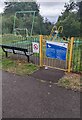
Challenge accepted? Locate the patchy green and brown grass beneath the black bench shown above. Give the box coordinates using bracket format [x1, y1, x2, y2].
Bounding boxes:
[0, 58, 39, 75]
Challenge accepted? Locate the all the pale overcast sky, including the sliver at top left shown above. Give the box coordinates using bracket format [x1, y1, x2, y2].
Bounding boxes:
[0, 0, 69, 23]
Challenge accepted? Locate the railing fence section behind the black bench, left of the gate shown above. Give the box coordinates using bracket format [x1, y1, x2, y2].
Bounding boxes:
[0, 34, 39, 65]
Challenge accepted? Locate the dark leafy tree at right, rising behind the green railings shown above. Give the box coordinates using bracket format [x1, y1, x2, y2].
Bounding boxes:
[56, 2, 81, 37]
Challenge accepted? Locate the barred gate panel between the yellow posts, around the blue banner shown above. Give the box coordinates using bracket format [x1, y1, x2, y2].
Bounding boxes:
[42, 36, 68, 71]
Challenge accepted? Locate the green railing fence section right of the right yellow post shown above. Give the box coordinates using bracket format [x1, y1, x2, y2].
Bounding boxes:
[72, 38, 82, 72]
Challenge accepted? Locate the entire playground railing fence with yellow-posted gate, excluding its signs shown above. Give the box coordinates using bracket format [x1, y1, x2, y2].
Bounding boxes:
[2, 34, 82, 72]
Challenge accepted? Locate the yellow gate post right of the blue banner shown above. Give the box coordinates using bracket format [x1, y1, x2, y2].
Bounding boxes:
[68, 37, 74, 72]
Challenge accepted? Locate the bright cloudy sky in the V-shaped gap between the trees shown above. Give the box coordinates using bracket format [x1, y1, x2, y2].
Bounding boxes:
[36, 0, 67, 23]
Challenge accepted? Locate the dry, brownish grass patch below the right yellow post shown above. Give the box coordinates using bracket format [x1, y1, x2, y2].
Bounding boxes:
[58, 73, 82, 92]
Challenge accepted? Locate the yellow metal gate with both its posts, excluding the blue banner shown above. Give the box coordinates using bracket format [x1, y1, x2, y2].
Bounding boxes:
[40, 35, 74, 72]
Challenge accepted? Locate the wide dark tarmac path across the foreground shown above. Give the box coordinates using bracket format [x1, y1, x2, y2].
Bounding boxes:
[2, 72, 80, 118]
